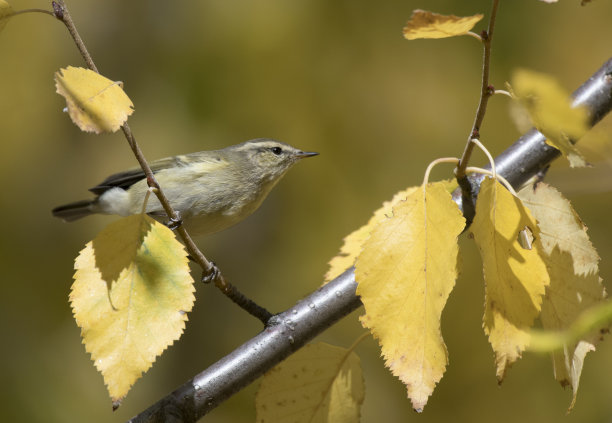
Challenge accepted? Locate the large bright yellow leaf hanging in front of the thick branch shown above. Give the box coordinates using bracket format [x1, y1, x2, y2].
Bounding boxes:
[355, 182, 465, 411]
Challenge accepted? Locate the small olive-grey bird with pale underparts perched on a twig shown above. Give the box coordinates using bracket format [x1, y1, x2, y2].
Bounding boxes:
[52, 138, 318, 235]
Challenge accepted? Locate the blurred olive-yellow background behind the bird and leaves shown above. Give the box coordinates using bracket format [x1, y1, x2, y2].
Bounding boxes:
[0, 0, 612, 423]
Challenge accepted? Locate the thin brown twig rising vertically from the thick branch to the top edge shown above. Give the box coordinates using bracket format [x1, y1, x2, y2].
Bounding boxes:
[455, 0, 499, 181]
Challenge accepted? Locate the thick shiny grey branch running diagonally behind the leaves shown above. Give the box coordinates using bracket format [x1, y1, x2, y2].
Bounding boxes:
[130, 59, 612, 423]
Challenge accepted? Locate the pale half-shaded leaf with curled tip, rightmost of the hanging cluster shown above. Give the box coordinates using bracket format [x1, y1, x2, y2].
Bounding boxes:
[519, 183, 606, 409]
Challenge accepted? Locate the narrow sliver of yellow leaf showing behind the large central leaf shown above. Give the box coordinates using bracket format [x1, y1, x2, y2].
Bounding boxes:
[325, 187, 418, 283]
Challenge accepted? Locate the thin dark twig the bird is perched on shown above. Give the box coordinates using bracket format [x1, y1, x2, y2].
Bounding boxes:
[51, 0, 272, 325]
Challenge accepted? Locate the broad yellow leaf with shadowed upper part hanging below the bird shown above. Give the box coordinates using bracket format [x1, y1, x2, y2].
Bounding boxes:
[70, 215, 194, 406]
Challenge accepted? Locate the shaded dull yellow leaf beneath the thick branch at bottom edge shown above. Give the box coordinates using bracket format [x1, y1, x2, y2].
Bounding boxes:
[255, 342, 365, 423]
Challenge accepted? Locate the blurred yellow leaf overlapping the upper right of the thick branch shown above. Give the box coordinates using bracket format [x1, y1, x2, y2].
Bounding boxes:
[512, 69, 589, 167]
